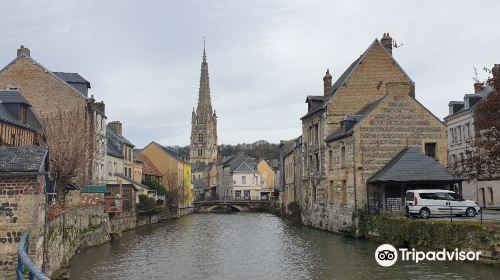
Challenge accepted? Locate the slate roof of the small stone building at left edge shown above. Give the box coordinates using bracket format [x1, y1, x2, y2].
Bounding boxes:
[0, 146, 48, 173]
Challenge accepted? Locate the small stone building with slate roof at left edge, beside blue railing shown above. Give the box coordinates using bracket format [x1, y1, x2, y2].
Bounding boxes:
[0, 146, 48, 279]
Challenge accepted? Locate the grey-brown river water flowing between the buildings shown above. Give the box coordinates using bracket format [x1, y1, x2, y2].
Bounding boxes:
[70, 212, 500, 280]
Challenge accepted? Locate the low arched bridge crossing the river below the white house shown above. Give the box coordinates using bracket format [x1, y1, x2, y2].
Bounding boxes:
[194, 200, 271, 213]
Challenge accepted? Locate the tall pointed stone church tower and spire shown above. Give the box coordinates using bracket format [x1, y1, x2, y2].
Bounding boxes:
[189, 48, 217, 164]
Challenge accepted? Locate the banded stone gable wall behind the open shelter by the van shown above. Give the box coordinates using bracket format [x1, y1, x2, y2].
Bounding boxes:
[354, 85, 448, 205]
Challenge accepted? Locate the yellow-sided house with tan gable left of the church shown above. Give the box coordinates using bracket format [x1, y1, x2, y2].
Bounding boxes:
[139, 142, 193, 215]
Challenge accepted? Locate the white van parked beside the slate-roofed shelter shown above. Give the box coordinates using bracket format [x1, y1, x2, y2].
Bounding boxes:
[405, 190, 481, 219]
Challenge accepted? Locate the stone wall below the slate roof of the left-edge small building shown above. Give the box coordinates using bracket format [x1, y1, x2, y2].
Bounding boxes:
[0, 175, 45, 279]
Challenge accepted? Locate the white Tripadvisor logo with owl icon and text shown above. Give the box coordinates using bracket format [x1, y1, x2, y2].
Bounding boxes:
[375, 244, 481, 267]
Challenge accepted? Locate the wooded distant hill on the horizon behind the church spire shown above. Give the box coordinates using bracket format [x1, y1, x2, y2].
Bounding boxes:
[170, 140, 279, 160]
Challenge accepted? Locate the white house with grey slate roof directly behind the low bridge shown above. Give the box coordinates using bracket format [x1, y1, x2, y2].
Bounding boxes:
[217, 153, 261, 200]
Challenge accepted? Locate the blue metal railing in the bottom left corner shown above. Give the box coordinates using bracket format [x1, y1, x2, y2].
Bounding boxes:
[16, 230, 50, 280]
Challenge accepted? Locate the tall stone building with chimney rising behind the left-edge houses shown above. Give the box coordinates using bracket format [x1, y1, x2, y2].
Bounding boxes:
[0, 46, 106, 186]
